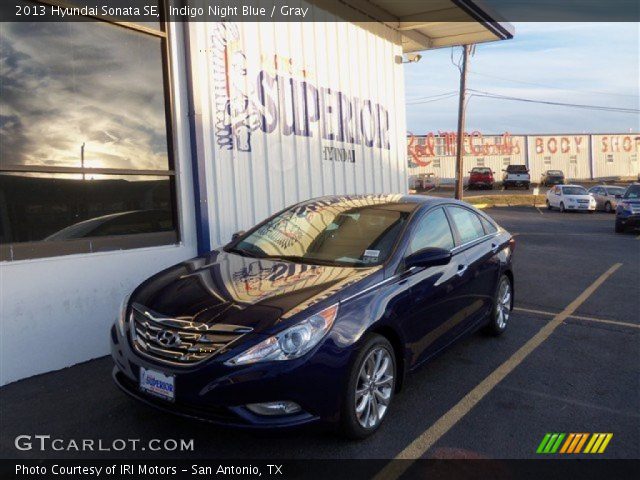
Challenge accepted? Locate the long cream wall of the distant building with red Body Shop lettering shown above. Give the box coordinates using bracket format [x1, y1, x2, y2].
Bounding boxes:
[407, 133, 640, 184]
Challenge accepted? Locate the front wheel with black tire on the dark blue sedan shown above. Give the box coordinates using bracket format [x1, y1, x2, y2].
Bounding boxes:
[340, 334, 397, 439]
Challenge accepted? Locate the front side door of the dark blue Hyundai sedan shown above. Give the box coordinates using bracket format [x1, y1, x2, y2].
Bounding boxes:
[399, 207, 471, 365]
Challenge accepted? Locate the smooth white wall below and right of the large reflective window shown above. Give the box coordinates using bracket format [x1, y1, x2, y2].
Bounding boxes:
[0, 23, 196, 385]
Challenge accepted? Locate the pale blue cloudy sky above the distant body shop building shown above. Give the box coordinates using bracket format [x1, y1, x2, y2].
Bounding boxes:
[405, 23, 640, 134]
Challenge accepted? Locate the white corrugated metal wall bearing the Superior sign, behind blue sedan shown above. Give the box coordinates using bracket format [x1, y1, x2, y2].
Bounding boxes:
[188, 15, 407, 245]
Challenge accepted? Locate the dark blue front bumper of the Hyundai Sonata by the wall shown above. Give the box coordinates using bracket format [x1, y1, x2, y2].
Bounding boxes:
[111, 326, 350, 428]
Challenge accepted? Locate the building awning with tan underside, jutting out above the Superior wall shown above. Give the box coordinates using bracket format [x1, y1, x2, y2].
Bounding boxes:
[344, 0, 514, 53]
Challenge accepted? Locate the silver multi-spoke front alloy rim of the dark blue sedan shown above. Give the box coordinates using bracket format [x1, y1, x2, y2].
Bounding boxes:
[355, 346, 394, 428]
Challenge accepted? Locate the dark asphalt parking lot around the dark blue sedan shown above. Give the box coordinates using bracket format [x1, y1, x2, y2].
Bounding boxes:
[0, 207, 640, 459]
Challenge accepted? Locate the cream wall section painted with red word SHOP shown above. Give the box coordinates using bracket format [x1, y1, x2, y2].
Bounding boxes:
[592, 133, 640, 177]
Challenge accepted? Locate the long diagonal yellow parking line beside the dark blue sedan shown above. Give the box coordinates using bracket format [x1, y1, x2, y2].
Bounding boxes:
[374, 263, 622, 480]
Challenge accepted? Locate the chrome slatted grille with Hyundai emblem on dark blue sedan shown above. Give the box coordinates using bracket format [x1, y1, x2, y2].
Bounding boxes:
[130, 303, 253, 365]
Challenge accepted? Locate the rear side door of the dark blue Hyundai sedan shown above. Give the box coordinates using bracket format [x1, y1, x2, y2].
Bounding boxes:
[446, 205, 500, 326]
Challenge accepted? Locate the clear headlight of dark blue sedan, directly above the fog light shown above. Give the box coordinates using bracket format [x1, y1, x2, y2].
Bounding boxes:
[225, 304, 338, 365]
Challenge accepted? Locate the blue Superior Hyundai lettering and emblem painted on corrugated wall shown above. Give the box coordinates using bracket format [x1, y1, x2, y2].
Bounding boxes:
[211, 22, 391, 157]
